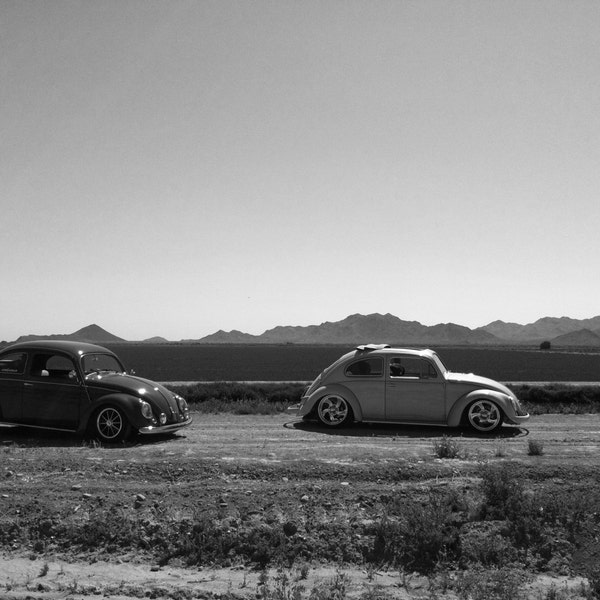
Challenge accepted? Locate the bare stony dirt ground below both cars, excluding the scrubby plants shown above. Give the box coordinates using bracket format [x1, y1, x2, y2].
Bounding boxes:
[0, 415, 600, 600]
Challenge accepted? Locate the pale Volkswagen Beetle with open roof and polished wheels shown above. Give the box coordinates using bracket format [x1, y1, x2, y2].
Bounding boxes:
[294, 344, 529, 433]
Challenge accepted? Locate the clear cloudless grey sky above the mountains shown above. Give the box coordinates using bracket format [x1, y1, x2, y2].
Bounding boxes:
[0, 0, 600, 341]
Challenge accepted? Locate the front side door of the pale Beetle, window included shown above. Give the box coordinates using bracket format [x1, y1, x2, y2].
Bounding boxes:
[385, 355, 446, 424]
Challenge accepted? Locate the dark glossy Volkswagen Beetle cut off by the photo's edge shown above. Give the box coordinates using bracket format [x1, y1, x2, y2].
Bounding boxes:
[0, 340, 192, 442]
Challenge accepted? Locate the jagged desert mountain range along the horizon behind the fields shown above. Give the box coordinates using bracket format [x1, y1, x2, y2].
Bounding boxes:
[3, 313, 600, 347]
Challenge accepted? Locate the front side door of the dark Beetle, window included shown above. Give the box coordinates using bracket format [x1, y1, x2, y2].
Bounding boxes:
[22, 352, 86, 430]
